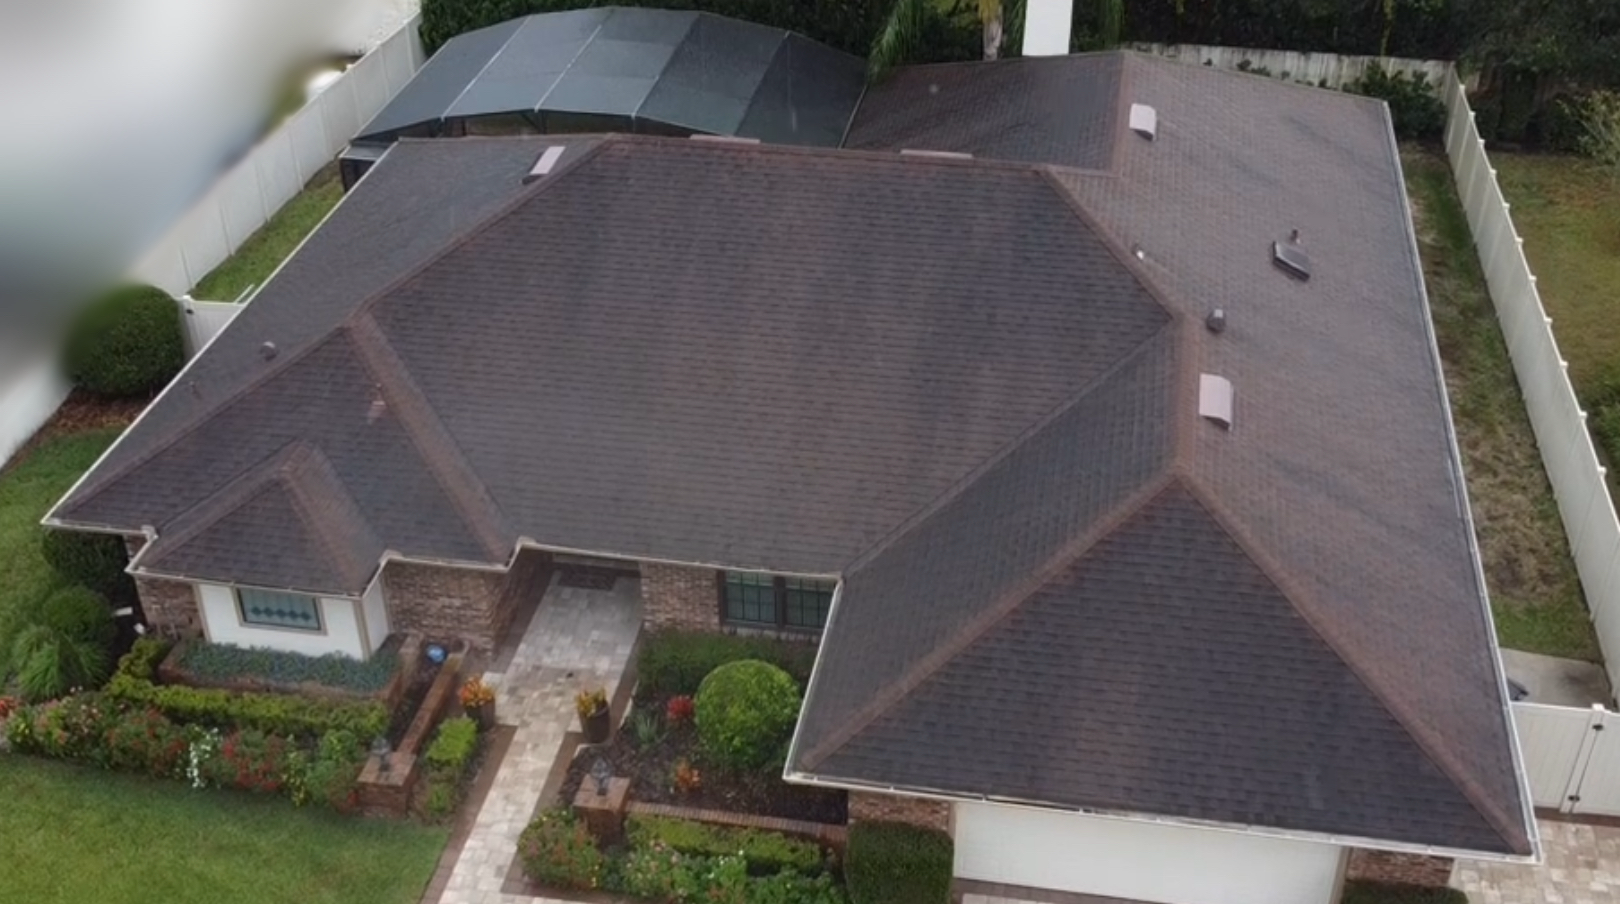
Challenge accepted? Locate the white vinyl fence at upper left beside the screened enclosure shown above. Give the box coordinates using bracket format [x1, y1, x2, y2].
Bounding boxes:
[131, 16, 423, 296]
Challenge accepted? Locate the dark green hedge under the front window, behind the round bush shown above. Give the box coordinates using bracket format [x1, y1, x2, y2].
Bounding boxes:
[635, 632, 815, 701]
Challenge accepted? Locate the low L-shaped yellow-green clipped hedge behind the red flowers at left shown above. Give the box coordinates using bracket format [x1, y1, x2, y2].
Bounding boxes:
[107, 638, 389, 739]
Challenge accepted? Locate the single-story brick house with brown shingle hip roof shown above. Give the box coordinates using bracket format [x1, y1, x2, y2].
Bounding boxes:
[47, 46, 1537, 904]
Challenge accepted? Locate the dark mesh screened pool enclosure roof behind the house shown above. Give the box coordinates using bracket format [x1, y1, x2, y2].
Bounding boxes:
[356, 6, 865, 147]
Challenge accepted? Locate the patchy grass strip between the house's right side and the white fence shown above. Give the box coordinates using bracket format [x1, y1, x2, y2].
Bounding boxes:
[1401, 149, 1602, 663]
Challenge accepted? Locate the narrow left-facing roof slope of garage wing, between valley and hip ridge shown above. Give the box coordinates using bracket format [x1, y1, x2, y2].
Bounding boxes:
[791, 326, 1178, 773]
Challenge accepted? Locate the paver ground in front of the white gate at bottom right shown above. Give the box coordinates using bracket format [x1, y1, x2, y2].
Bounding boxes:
[1452, 820, 1620, 904]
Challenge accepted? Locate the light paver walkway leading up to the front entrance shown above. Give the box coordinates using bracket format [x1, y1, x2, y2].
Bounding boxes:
[439, 578, 642, 904]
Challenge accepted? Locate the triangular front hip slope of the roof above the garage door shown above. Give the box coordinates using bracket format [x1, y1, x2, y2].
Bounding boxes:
[813, 480, 1520, 852]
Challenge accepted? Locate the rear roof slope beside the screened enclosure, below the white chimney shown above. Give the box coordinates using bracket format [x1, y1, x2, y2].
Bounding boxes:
[844, 53, 1129, 170]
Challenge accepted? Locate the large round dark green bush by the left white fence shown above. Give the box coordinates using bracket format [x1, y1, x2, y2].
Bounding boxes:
[63, 285, 186, 397]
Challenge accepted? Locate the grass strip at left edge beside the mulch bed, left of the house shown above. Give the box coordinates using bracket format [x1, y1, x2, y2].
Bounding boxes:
[0, 429, 122, 631]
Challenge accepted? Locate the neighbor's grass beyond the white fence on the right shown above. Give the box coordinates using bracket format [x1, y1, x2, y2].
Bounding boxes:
[1490, 154, 1620, 390]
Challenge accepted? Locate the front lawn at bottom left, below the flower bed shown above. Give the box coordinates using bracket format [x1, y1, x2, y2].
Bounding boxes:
[0, 757, 447, 904]
